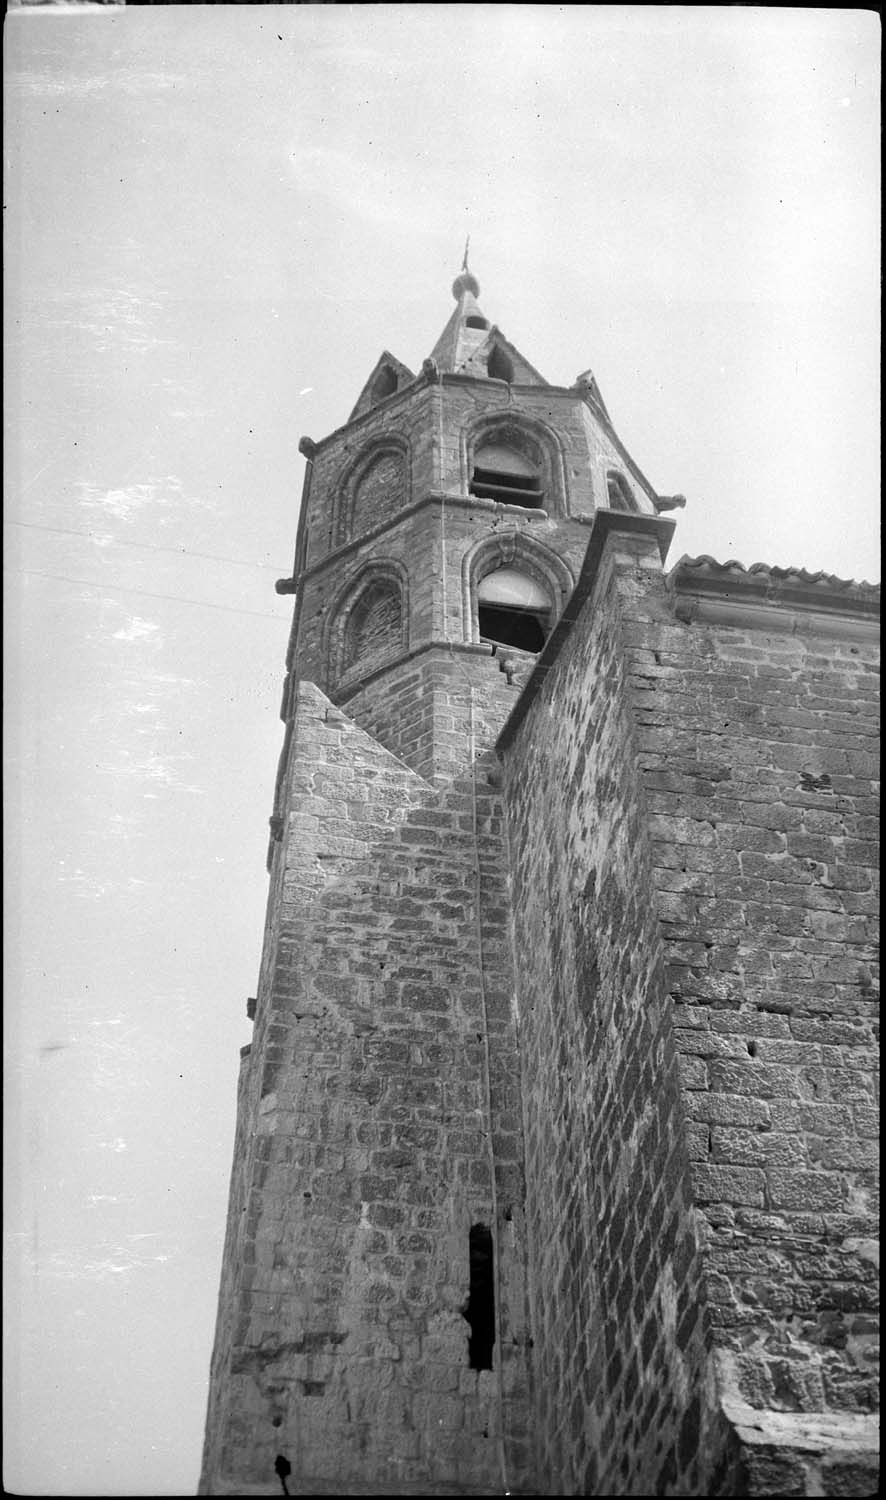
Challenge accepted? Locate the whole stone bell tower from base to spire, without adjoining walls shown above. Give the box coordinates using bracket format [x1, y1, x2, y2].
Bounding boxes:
[201, 264, 682, 1496]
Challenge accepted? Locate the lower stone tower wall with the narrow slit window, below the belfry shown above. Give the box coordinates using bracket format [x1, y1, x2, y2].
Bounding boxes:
[201, 684, 535, 1494]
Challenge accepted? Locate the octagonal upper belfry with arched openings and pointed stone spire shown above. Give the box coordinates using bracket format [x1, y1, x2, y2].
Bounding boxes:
[266, 257, 661, 782]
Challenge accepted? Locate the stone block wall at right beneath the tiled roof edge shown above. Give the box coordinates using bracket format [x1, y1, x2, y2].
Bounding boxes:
[625, 581, 879, 1494]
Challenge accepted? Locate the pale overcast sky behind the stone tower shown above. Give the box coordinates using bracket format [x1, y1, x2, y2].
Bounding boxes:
[4, 5, 880, 1496]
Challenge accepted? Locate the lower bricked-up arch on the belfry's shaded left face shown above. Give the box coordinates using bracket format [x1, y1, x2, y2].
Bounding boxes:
[324, 560, 409, 686]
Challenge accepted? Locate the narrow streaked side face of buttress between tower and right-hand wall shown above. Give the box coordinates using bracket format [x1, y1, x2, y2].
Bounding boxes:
[504, 540, 718, 1496]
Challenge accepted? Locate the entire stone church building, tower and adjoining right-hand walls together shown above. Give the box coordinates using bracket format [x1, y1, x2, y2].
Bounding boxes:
[199, 261, 879, 1496]
